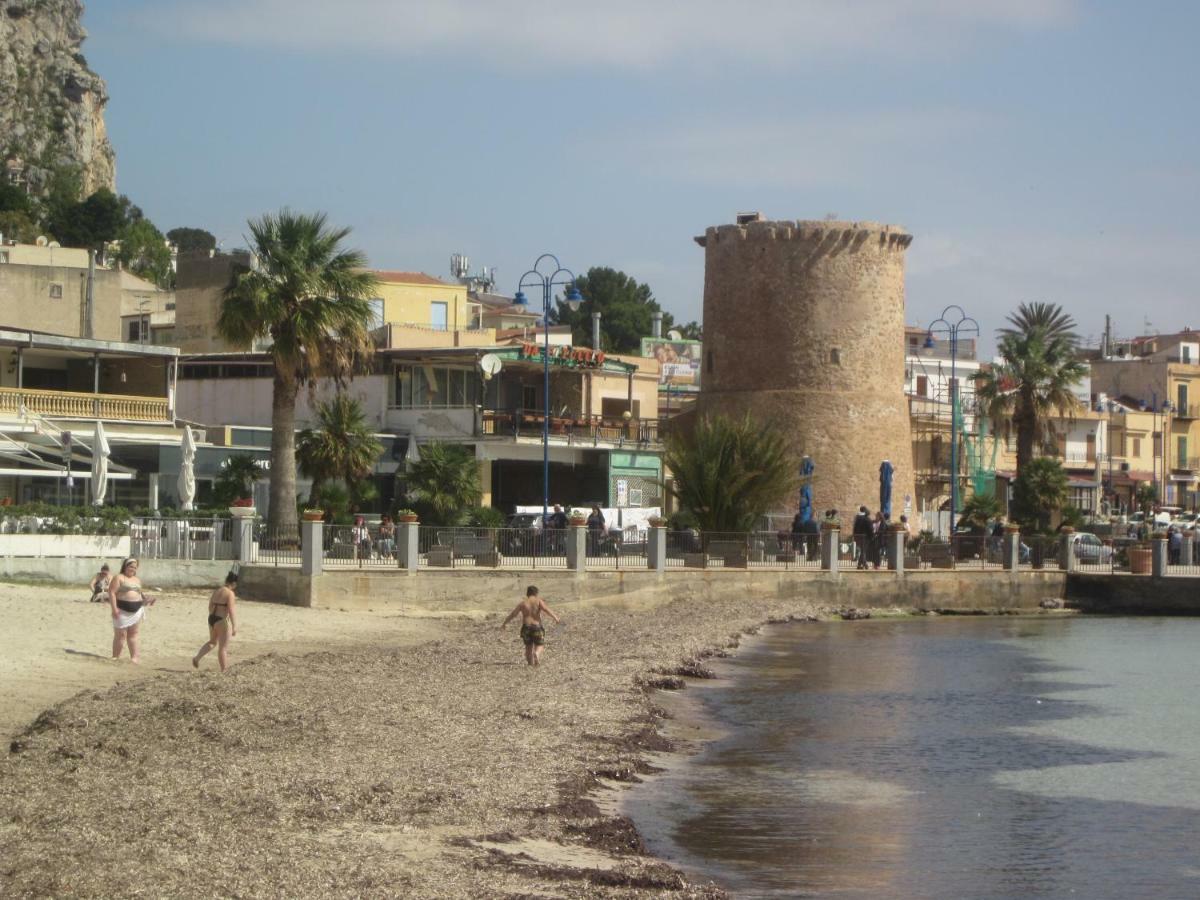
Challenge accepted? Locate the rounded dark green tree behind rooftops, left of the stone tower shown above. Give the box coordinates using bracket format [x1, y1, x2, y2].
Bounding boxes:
[550, 268, 674, 353]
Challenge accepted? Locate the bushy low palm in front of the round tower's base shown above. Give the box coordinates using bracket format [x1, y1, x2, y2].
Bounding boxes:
[662, 415, 799, 532]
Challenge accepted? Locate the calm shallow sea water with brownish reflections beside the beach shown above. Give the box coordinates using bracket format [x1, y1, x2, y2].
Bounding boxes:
[625, 616, 1200, 899]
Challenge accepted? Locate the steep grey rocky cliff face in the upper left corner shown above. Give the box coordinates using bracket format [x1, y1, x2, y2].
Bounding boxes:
[0, 0, 116, 197]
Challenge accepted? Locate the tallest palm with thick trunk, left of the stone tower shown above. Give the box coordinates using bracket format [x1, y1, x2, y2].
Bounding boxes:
[217, 209, 378, 529]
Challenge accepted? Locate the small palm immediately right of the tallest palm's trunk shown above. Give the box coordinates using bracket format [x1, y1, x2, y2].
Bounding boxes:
[296, 391, 383, 504]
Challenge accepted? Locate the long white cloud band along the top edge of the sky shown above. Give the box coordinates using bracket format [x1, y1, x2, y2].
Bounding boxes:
[133, 0, 1080, 68]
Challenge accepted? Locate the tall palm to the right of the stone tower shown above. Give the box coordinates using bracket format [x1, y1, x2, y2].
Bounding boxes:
[974, 305, 1087, 475]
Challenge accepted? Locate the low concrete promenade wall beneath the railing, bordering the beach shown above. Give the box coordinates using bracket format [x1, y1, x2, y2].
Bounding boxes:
[239, 565, 1066, 614]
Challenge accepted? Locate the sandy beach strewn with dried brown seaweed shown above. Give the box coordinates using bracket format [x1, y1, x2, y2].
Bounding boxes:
[0, 580, 817, 898]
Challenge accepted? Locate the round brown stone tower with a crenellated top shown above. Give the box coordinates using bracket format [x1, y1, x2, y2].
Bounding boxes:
[696, 214, 916, 520]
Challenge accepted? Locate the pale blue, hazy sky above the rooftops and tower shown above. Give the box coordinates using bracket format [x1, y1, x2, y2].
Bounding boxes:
[84, 0, 1200, 347]
